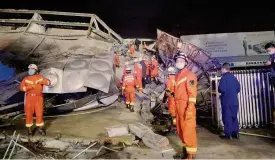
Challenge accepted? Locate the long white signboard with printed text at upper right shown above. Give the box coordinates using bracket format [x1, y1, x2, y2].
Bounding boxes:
[180, 31, 274, 57]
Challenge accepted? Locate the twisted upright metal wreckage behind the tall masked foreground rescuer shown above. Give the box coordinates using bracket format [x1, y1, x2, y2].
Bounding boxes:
[156, 30, 220, 109]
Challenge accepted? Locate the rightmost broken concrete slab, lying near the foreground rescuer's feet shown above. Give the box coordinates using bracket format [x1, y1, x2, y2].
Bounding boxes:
[142, 133, 169, 151]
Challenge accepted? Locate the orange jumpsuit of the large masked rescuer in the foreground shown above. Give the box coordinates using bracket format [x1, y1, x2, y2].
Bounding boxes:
[175, 69, 197, 155]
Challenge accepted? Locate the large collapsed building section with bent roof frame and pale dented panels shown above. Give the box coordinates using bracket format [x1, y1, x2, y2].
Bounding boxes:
[0, 9, 123, 111]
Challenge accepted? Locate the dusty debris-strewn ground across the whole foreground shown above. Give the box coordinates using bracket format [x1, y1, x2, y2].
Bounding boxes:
[0, 52, 275, 159]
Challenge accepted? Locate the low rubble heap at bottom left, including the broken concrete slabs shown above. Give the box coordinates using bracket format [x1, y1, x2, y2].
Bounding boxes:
[0, 122, 174, 159]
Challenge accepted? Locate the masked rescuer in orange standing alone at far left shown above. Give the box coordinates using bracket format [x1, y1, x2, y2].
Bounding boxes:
[20, 64, 50, 136]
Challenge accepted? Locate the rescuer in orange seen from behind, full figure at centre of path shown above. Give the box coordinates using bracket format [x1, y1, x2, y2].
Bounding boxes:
[122, 67, 139, 112]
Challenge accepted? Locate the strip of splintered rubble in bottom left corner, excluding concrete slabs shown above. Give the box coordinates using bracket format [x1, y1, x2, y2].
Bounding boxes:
[0, 131, 127, 159]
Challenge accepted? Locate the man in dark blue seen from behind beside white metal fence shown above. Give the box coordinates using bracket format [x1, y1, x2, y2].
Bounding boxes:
[218, 63, 240, 139]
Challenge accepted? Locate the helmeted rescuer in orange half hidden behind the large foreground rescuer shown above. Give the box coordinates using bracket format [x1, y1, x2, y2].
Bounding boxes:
[166, 67, 176, 125]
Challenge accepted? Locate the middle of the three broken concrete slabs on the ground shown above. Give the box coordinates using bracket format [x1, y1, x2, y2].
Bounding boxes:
[129, 122, 154, 138]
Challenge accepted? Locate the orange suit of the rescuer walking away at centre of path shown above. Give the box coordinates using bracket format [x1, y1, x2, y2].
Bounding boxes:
[122, 74, 137, 105]
